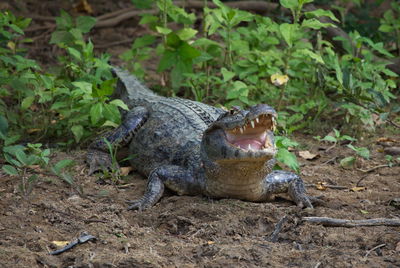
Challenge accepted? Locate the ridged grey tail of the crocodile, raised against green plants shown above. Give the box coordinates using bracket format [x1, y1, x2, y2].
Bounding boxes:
[112, 67, 157, 103]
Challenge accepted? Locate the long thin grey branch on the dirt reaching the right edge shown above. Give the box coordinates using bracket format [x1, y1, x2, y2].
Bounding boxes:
[302, 217, 400, 228]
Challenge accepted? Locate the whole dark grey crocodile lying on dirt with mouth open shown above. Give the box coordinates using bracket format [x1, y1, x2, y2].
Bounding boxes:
[86, 68, 313, 210]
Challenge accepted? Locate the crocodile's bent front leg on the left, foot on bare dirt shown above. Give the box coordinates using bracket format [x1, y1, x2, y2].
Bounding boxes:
[128, 165, 204, 210]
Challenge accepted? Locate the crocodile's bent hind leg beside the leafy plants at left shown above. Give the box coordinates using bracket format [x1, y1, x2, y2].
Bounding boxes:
[86, 107, 149, 175]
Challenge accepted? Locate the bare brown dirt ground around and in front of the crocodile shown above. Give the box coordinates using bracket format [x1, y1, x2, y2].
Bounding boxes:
[0, 0, 400, 268]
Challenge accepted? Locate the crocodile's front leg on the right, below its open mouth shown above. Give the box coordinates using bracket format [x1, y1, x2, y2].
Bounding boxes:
[264, 170, 313, 208]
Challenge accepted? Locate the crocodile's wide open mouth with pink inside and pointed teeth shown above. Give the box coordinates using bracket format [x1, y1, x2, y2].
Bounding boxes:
[225, 114, 276, 151]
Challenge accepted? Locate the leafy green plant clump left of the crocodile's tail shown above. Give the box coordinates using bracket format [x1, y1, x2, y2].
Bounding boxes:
[0, 11, 128, 145]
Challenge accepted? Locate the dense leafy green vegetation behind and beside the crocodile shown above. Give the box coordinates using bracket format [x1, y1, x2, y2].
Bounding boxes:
[0, 0, 400, 180]
